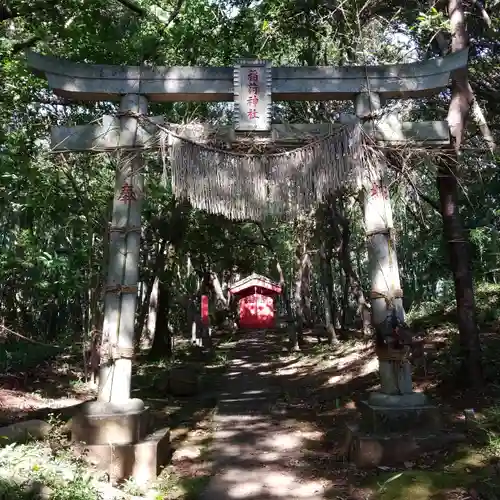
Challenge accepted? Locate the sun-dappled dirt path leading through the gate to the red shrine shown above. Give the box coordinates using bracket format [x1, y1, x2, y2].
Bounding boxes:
[201, 332, 348, 500]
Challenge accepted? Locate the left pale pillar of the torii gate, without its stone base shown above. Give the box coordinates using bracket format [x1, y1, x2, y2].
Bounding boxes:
[98, 94, 148, 403]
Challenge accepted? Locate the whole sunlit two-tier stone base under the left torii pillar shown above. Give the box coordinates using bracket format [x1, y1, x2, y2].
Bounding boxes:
[71, 399, 171, 485]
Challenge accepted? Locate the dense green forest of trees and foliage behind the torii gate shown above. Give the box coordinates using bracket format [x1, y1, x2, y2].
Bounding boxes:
[0, 0, 500, 380]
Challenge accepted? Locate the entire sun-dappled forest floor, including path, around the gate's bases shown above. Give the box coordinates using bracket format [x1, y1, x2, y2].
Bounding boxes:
[0, 308, 500, 500]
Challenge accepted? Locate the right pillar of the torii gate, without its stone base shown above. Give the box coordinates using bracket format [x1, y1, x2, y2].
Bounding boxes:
[354, 93, 413, 399]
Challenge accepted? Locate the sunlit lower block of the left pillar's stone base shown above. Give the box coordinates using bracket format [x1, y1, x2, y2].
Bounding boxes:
[74, 428, 171, 485]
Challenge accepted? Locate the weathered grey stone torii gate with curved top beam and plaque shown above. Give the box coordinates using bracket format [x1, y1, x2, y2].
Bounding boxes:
[28, 47, 468, 476]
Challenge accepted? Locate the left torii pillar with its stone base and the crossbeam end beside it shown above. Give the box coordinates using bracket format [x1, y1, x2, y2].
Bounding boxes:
[52, 93, 170, 483]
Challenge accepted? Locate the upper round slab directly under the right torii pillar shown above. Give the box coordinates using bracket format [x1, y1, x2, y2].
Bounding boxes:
[359, 401, 441, 432]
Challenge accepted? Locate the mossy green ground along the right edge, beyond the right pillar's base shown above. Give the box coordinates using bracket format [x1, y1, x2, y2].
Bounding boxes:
[363, 284, 500, 500]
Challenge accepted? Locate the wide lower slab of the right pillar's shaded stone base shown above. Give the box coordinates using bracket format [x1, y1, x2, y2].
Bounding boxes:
[344, 424, 465, 468]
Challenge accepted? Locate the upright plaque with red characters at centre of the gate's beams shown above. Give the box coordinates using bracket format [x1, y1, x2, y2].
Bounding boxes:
[234, 60, 272, 132]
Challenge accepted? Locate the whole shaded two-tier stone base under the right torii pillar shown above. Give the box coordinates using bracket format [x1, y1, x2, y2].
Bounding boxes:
[343, 392, 465, 468]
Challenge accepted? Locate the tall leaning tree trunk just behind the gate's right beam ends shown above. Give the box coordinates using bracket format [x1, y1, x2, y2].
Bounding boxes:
[437, 0, 483, 387]
